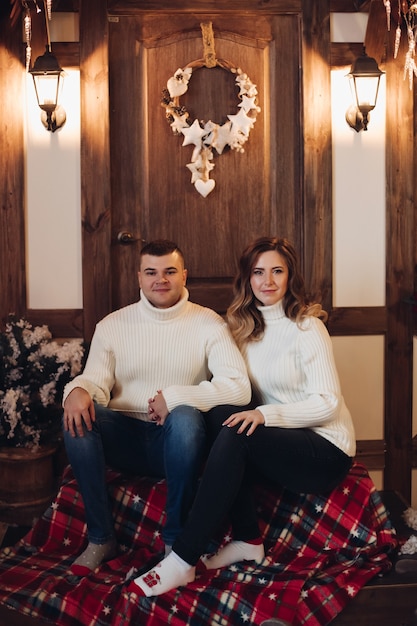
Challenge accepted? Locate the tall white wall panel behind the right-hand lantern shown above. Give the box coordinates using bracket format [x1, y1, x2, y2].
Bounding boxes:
[331, 68, 385, 307]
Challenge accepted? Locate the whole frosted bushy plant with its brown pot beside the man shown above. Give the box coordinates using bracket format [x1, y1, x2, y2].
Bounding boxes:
[0, 315, 85, 522]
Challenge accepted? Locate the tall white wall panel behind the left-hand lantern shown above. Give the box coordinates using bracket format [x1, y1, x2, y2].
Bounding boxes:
[26, 70, 82, 309]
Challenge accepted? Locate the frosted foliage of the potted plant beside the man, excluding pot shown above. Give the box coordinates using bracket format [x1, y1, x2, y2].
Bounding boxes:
[0, 315, 84, 448]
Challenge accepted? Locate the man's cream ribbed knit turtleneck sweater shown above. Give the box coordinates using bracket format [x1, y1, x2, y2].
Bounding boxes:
[63, 288, 251, 419]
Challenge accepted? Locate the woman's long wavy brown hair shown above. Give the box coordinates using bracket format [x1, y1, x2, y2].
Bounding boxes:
[227, 237, 327, 347]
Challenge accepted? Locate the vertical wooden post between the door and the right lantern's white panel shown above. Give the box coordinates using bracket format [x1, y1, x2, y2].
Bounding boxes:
[300, 0, 332, 311]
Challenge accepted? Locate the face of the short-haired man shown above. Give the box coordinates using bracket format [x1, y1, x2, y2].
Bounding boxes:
[138, 252, 187, 309]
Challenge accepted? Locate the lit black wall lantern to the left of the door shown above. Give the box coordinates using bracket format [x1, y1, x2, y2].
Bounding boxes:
[29, 44, 66, 133]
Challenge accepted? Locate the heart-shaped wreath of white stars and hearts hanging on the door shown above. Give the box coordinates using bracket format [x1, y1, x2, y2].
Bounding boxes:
[162, 60, 261, 198]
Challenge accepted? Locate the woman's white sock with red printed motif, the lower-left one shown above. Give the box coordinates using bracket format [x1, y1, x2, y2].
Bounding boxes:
[130, 552, 195, 598]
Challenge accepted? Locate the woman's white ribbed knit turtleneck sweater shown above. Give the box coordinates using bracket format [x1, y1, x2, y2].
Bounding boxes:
[244, 301, 356, 456]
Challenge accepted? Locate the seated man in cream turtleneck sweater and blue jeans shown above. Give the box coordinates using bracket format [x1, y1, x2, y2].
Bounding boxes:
[63, 240, 251, 576]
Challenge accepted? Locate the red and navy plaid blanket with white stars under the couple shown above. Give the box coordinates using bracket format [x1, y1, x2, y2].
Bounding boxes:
[0, 464, 397, 626]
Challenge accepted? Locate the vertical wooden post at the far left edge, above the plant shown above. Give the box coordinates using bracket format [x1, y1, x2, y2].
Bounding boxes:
[0, 16, 26, 321]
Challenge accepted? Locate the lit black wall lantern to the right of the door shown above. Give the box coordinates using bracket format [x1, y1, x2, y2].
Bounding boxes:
[346, 48, 385, 132]
